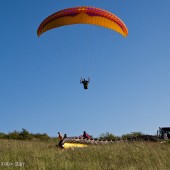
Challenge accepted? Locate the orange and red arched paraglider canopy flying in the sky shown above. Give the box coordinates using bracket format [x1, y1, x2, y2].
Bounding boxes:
[37, 6, 128, 37]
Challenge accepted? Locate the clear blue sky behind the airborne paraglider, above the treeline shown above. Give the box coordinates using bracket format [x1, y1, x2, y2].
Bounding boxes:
[0, 0, 170, 137]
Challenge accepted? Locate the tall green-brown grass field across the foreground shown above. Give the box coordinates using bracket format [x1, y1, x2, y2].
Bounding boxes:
[0, 139, 170, 170]
